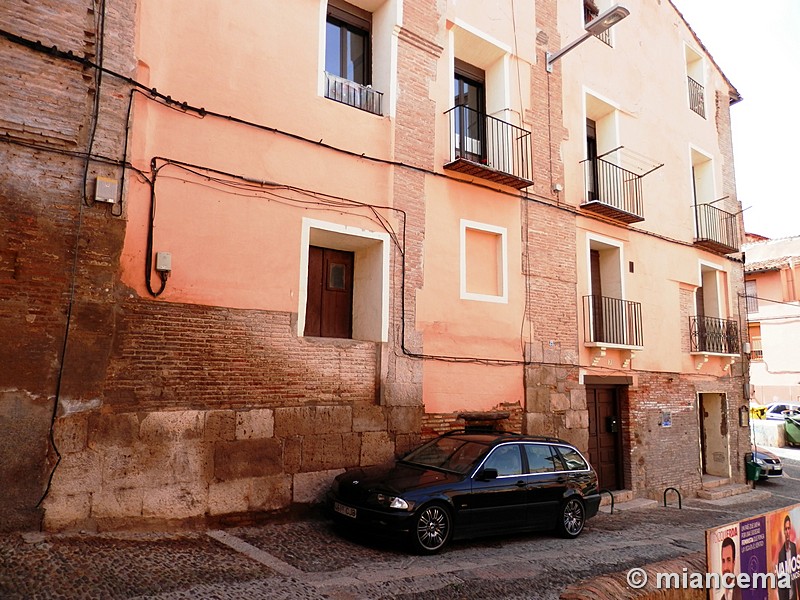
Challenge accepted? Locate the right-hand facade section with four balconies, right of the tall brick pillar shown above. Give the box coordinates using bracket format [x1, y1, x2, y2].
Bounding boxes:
[554, 2, 749, 494]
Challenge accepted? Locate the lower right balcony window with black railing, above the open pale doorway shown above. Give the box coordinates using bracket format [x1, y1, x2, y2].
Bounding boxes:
[689, 264, 739, 355]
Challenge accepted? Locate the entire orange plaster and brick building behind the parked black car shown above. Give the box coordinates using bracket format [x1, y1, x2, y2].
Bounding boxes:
[0, 0, 749, 530]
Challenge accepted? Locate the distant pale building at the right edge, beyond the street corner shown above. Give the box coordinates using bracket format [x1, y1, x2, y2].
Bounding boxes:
[743, 236, 800, 404]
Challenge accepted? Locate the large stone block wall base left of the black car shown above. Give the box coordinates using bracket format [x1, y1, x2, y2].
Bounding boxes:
[44, 404, 406, 531]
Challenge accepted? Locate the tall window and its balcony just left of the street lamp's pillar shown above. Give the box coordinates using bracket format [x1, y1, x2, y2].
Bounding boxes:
[444, 25, 533, 189]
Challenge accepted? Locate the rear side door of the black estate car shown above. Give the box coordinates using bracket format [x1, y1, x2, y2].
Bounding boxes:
[523, 443, 569, 529]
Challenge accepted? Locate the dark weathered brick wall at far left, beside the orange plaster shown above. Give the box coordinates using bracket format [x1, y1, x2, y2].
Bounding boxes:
[0, 0, 135, 529]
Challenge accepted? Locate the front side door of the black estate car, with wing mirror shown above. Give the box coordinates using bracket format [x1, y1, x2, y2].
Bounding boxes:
[463, 443, 528, 533]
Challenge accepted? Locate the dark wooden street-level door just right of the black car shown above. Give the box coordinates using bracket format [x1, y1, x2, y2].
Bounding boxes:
[586, 387, 623, 490]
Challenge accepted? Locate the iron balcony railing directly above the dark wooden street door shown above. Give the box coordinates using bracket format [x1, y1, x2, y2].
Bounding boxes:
[583, 295, 644, 348]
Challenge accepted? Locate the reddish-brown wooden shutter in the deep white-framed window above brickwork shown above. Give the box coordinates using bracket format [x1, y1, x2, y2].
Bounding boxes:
[304, 246, 354, 338]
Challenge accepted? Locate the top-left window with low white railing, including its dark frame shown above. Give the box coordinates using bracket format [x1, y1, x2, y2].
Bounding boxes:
[325, 0, 382, 114]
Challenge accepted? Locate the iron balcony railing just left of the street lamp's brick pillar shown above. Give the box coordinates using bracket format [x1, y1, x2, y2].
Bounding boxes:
[444, 105, 533, 189]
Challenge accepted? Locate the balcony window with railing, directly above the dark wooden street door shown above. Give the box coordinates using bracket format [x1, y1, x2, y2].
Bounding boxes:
[583, 239, 644, 348]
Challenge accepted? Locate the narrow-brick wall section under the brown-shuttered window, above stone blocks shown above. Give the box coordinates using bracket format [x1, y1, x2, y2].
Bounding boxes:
[104, 300, 380, 411]
